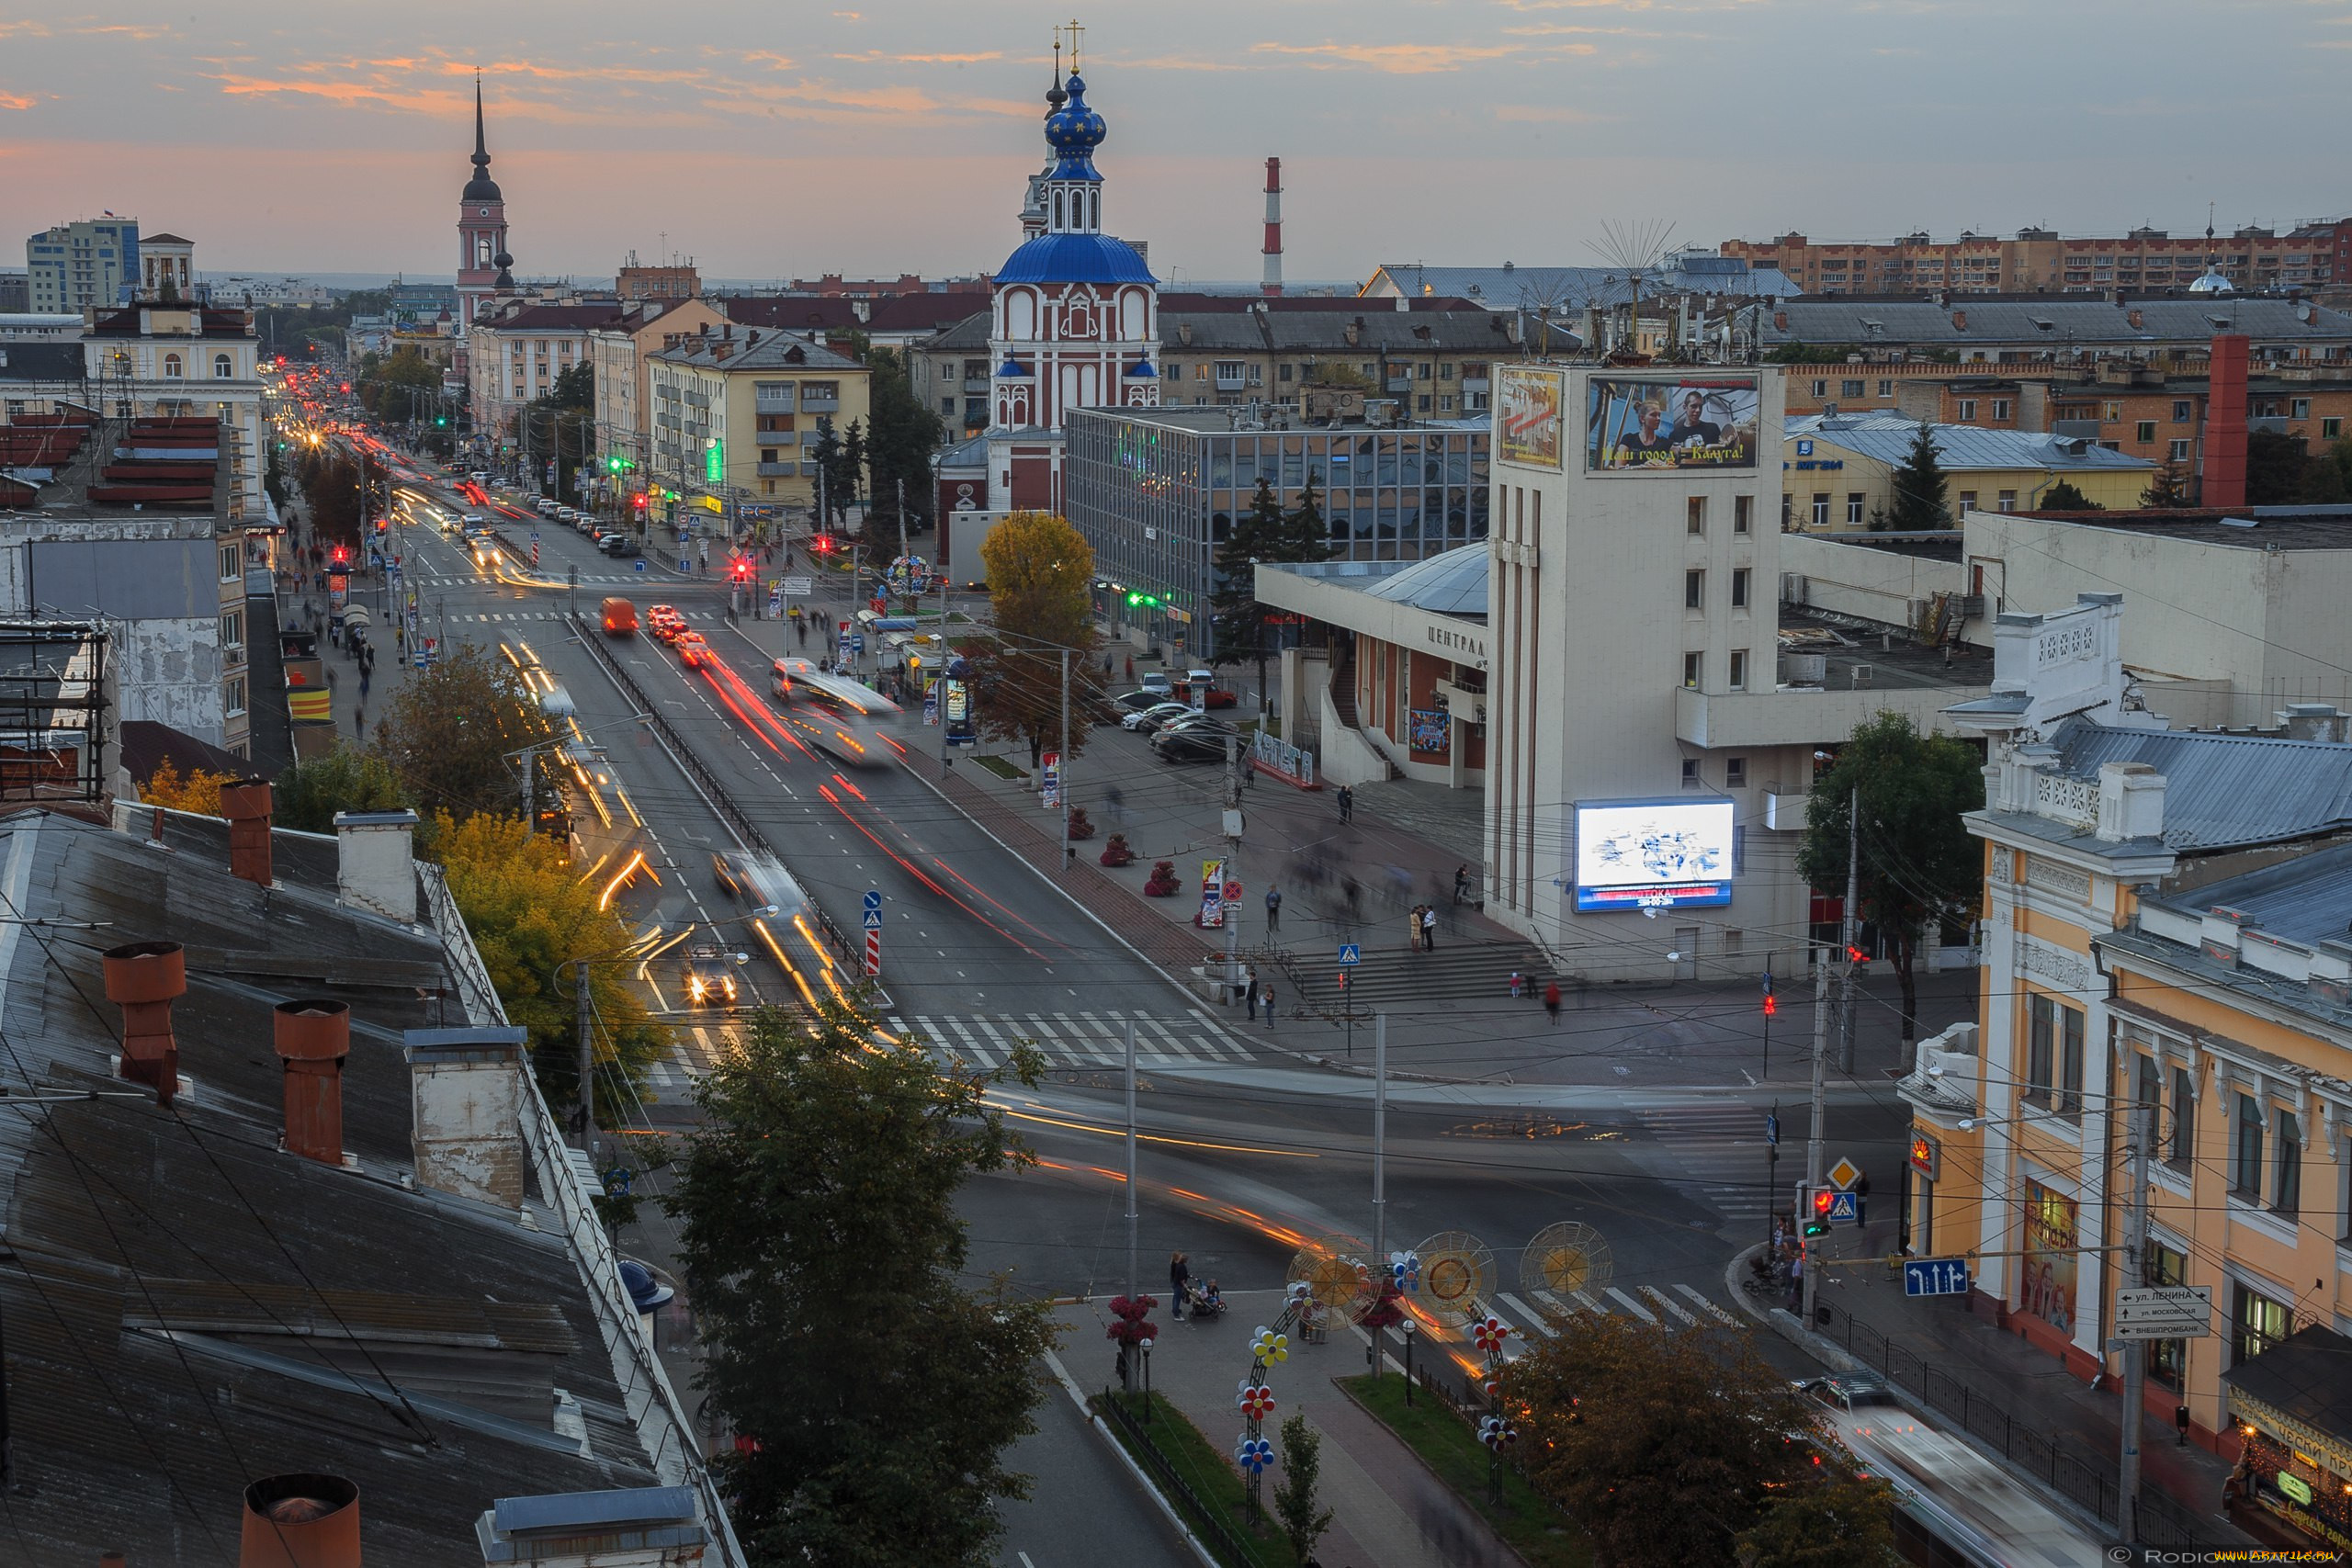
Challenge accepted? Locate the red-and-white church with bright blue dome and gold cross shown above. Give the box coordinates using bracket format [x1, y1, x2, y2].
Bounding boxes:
[988, 40, 1159, 513]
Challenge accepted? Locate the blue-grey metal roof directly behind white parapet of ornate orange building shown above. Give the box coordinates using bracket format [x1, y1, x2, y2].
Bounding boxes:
[2055, 719, 2352, 851]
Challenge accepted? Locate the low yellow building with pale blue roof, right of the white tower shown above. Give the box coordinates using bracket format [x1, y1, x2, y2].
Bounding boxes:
[1781, 413, 2157, 529]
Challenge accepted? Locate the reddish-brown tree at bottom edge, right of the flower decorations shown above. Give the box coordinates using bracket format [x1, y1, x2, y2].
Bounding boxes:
[1503, 1312, 1891, 1568]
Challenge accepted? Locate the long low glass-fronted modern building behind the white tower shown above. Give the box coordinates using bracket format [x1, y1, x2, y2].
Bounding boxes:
[1068, 409, 1488, 659]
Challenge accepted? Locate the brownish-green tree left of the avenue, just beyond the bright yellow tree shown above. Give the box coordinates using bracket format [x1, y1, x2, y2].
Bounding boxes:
[371, 642, 555, 820]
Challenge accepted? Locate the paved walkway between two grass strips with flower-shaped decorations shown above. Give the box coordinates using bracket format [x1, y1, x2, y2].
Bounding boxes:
[1056, 1291, 1520, 1568]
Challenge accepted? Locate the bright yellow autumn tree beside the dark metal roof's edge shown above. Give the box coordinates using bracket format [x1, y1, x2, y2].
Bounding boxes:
[430, 811, 668, 1126]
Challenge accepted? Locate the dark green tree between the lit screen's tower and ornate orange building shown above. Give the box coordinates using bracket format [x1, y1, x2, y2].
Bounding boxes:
[1797, 712, 1985, 1042]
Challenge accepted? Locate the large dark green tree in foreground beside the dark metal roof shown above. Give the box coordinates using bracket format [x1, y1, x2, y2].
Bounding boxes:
[663, 1004, 1054, 1568]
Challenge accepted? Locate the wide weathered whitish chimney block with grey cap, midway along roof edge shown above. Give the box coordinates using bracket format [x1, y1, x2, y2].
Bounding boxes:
[400, 1027, 529, 1211]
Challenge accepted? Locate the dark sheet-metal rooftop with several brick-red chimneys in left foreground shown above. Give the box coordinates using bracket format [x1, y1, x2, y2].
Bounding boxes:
[0, 804, 741, 1568]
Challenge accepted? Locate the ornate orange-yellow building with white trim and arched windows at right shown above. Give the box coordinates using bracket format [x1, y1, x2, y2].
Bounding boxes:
[1898, 594, 2352, 1547]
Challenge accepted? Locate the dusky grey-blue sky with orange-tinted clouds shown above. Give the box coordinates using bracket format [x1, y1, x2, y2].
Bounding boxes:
[0, 0, 2352, 282]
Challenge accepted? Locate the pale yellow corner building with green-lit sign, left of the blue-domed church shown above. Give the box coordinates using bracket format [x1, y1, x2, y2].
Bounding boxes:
[647, 324, 870, 526]
